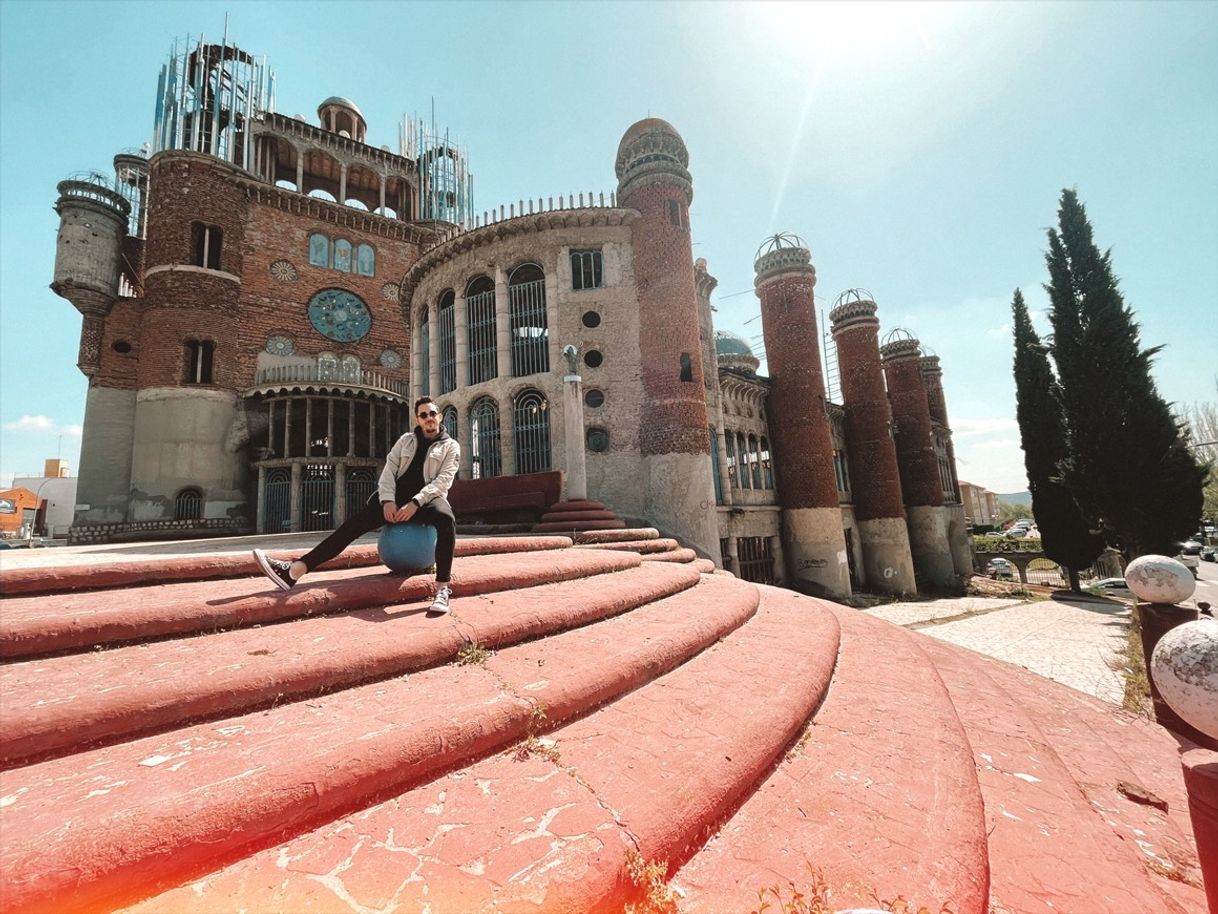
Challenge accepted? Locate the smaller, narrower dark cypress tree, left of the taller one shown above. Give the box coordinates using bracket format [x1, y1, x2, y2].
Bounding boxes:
[1011, 289, 1104, 593]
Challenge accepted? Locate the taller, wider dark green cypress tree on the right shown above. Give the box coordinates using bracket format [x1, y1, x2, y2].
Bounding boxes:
[1045, 190, 1206, 558]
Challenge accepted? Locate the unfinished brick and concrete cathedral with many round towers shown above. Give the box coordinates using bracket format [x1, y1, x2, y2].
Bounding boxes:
[51, 28, 972, 597]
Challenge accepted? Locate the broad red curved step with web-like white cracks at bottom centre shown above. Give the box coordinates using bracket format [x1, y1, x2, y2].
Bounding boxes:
[116, 587, 838, 914]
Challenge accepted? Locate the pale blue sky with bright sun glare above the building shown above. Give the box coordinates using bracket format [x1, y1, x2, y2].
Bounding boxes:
[0, 0, 1218, 492]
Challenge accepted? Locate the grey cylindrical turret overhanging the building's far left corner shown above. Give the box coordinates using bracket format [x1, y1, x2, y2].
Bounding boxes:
[51, 173, 132, 377]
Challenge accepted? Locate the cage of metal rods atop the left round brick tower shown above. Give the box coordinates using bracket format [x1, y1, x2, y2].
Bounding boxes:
[152, 22, 275, 168]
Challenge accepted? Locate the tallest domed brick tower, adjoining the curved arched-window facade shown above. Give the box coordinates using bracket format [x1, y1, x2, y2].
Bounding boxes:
[616, 118, 719, 557]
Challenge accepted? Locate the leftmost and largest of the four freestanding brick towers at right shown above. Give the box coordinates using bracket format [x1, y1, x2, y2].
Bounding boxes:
[753, 234, 850, 597]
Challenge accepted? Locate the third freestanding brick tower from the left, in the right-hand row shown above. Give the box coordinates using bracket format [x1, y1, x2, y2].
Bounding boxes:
[879, 330, 956, 587]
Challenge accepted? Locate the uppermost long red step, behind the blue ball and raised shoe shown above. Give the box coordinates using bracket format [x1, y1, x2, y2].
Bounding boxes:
[0, 534, 571, 596]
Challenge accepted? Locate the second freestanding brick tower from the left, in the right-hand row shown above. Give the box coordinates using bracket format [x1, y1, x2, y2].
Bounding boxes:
[829, 289, 917, 593]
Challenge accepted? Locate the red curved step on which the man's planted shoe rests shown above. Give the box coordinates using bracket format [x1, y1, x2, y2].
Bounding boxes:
[0, 565, 699, 765]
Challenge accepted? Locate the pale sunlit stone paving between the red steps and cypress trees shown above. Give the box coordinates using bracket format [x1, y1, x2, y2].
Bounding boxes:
[866, 597, 1130, 704]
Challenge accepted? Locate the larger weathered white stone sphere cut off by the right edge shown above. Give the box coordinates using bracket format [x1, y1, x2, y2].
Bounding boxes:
[1151, 619, 1218, 740]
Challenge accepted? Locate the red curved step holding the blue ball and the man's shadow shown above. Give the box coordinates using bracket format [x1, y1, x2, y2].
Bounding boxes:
[0, 548, 639, 658]
